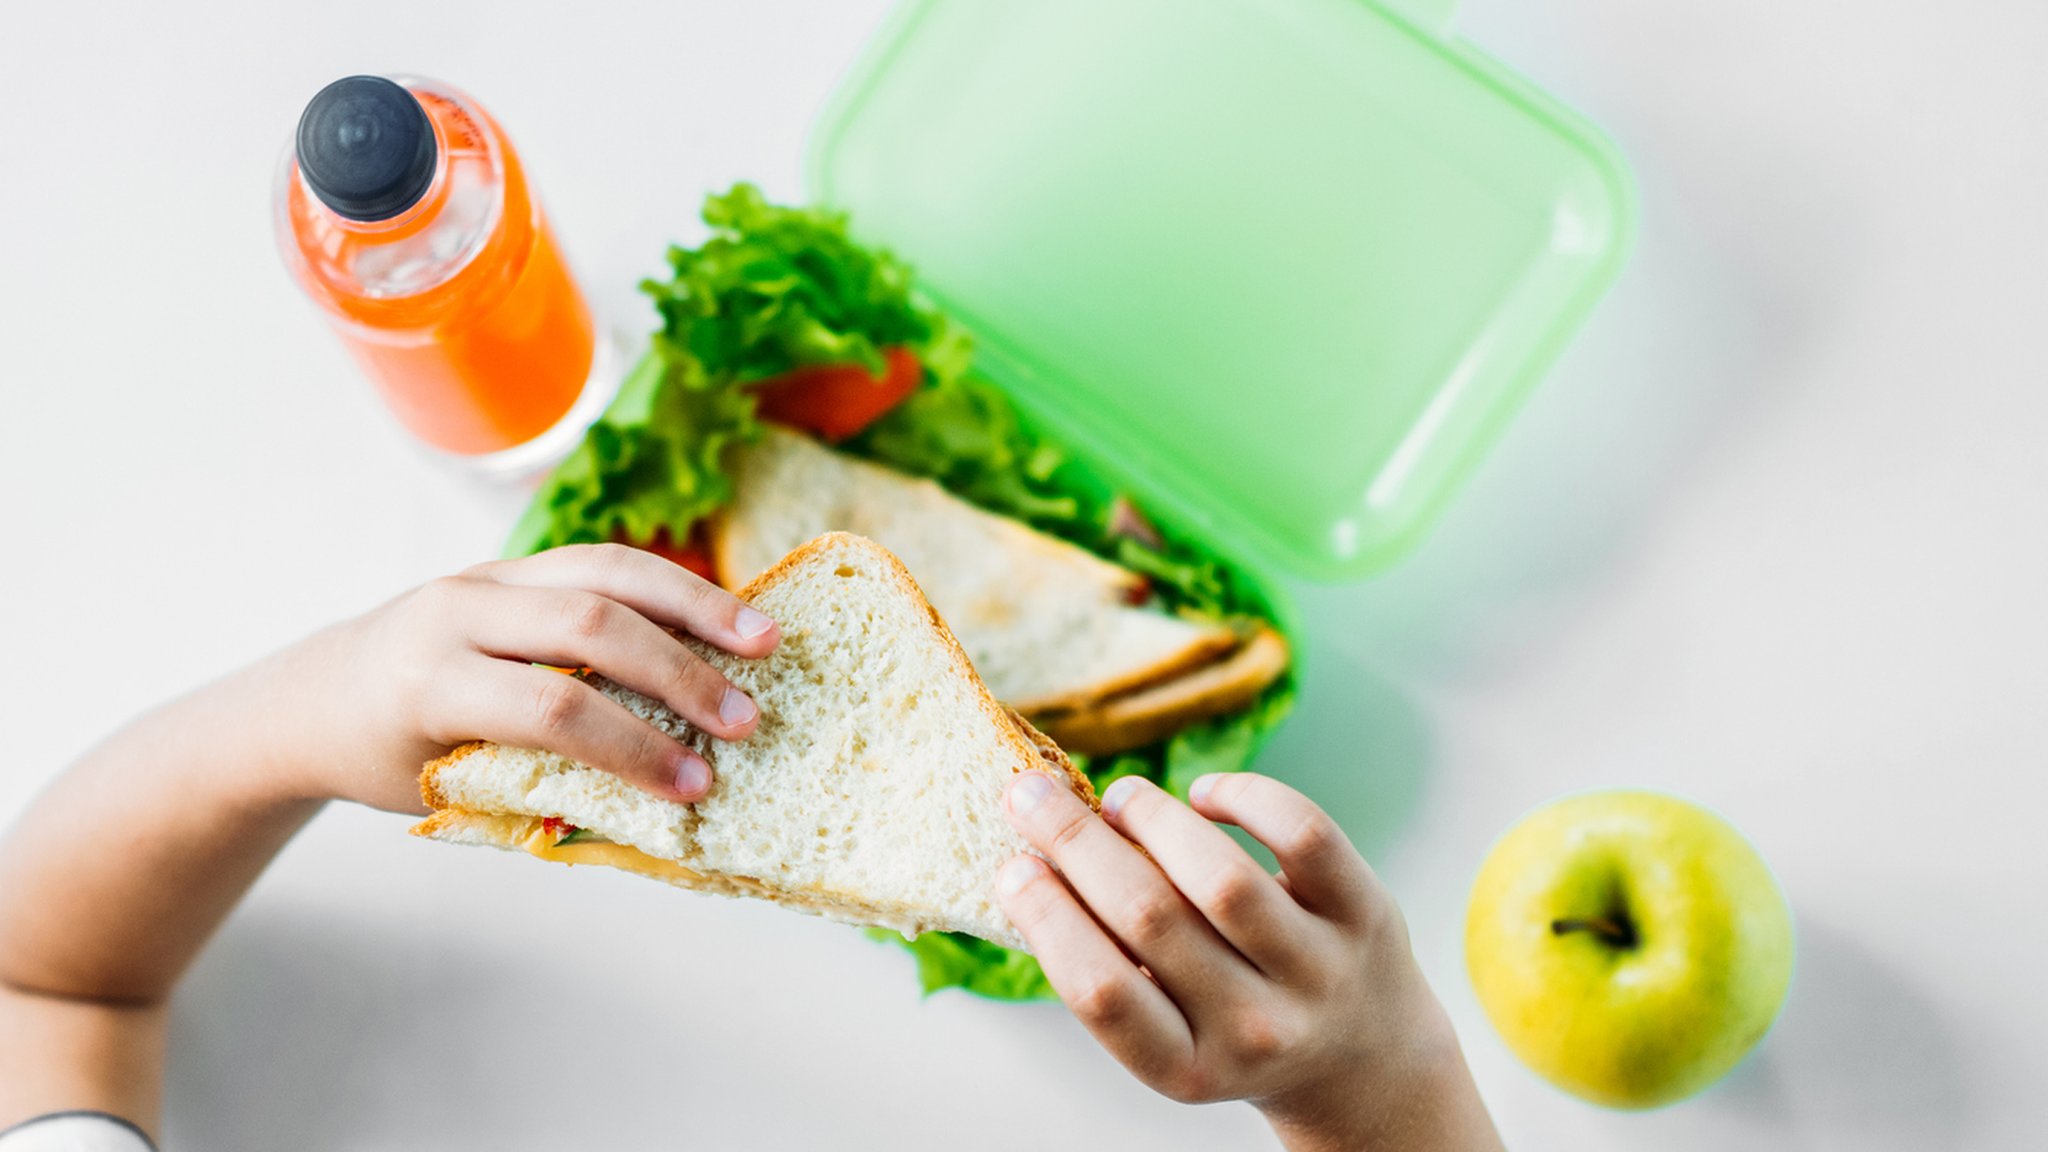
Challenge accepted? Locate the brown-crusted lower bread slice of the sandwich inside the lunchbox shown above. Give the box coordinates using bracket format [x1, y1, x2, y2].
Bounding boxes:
[1038, 627, 1288, 756]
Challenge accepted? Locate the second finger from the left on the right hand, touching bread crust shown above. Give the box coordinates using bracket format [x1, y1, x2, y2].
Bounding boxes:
[1008, 773, 1251, 1004]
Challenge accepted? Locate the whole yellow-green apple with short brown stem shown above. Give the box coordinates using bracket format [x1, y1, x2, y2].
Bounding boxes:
[1464, 791, 1792, 1109]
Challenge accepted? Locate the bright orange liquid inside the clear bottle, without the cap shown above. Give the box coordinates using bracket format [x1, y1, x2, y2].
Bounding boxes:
[289, 92, 596, 455]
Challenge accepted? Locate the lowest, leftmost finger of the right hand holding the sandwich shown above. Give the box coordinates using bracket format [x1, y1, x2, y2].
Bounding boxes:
[995, 857, 1194, 1080]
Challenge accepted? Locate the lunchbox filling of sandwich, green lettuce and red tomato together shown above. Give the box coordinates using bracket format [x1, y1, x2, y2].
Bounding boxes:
[506, 184, 1294, 998]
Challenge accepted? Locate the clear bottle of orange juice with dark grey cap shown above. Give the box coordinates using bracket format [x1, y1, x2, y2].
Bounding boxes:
[276, 76, 616, 474]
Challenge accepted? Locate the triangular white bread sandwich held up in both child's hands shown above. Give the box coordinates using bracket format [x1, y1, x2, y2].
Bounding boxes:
[414, 533, 1094, 947]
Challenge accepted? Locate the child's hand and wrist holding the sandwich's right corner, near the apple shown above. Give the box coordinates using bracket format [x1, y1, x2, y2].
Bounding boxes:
[997, 773, 1499, 1150]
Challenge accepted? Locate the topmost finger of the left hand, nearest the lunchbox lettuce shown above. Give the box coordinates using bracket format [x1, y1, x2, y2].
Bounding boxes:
[469, 543, 780, 658]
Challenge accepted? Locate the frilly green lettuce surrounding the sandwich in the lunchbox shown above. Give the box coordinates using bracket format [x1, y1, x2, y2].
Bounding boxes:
[506, 184, 1294, 1000]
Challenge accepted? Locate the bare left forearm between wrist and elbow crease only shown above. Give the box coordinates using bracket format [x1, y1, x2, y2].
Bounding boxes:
[0, 637, 342, 1004]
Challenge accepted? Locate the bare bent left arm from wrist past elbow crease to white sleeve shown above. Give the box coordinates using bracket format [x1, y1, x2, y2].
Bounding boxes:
[0, 635, 335, 1127]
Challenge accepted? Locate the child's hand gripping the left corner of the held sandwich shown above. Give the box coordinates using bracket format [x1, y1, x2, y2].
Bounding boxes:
[281, 543, 778, 812]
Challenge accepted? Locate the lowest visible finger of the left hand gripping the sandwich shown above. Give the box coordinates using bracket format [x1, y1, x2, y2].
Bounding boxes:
[444, 660, 711, 804]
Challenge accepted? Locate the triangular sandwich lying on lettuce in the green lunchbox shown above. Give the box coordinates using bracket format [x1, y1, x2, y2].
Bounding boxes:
[711, 424, 1288, 754]
